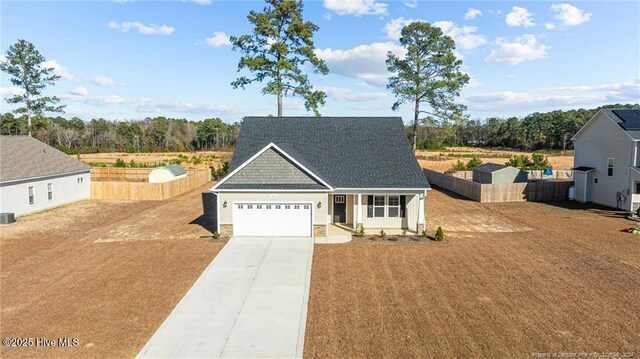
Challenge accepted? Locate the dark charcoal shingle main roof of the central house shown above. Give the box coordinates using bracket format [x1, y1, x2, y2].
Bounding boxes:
[230, 117, 430, 188]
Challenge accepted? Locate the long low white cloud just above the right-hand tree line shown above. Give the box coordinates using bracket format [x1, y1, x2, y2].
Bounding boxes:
[463, 79, 640, 114]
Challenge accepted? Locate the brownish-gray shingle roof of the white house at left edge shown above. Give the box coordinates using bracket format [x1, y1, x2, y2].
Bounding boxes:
[0, 136, 91, 182]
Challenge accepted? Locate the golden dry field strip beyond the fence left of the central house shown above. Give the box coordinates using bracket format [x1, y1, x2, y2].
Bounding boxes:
[80, 151, 233, 168]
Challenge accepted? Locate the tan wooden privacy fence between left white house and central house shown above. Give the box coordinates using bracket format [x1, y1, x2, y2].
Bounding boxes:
[91, 169, 211, 201]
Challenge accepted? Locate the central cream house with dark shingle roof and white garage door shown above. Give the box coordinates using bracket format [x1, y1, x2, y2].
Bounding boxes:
[211, 117, 430, 236]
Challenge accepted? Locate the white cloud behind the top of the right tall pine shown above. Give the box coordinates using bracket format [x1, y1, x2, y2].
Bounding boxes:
[384, 17, 487, 50]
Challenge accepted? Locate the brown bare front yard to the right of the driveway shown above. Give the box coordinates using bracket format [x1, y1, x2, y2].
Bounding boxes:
[304, 190, 640, 358]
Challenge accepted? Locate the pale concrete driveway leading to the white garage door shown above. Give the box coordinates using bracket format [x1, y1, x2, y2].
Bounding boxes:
[138, 237, 313, 358]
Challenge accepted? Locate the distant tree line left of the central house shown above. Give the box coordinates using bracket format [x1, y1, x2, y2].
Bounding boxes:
[0, 113, 240, 154]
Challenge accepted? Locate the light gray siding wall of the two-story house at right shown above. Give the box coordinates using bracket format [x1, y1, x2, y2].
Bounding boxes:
[574, 112, 635, 210]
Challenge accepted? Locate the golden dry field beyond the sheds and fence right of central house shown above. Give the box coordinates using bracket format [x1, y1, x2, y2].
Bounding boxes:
[416, 147, 573, 172]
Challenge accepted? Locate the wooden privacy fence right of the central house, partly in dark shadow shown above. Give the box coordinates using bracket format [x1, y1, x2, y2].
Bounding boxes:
[423, 169, 573, 203]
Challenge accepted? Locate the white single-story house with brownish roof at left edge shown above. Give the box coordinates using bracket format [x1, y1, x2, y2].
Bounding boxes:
[0, 136, 91, 216]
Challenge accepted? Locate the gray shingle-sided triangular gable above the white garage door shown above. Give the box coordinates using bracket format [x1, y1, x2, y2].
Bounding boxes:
[226, 148, 317, 184]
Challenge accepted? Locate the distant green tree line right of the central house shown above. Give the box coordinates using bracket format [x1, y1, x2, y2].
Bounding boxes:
[417, 104, 640, 151]
